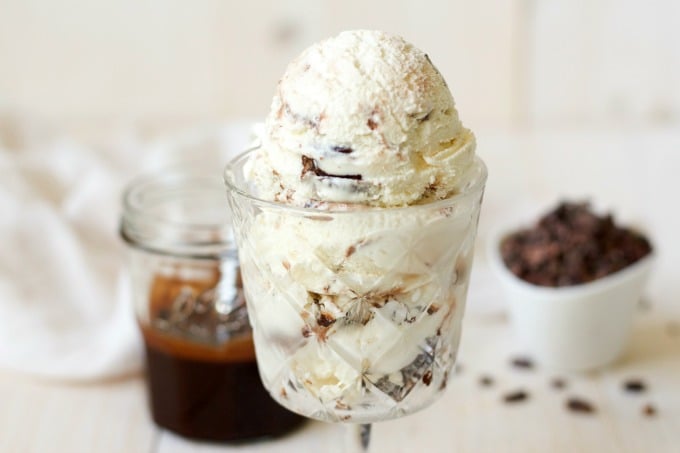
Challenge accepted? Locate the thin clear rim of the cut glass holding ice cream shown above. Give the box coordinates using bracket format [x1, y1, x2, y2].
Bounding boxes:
[223, 146, 488, 215]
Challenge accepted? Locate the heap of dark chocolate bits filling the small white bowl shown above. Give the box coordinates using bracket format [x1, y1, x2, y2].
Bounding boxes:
[501, 202, 652, 287]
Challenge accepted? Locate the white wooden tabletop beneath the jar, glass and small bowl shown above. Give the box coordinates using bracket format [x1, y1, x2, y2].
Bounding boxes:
[0, 126, 680, 453]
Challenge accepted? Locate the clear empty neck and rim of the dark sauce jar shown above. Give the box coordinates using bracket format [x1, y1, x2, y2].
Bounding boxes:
[119, 165, 233, 259]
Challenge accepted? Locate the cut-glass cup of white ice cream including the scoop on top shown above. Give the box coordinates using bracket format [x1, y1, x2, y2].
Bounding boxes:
[226, 31, 486, 423]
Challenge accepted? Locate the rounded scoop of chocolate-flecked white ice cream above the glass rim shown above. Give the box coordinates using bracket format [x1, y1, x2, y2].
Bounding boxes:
[249, 30, 475, 207]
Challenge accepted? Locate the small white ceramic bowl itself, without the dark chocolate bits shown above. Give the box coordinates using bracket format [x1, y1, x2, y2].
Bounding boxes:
[487, 226, 653, 371]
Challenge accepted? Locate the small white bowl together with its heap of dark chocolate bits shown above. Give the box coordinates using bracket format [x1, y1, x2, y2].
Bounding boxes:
[488, 201, 654, 370]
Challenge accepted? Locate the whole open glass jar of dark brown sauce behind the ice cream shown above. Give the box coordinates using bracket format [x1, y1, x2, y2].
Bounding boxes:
[120, 168, 305, 442]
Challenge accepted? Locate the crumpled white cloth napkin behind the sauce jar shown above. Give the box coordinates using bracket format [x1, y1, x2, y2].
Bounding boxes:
[0, 116, 254, 380]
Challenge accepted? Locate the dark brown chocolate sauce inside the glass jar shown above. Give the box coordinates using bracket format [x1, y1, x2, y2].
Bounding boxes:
[140, 272, 305, 442]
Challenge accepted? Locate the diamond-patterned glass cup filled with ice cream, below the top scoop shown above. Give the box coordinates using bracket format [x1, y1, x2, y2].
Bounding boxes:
[225, 153, 486, 423]
